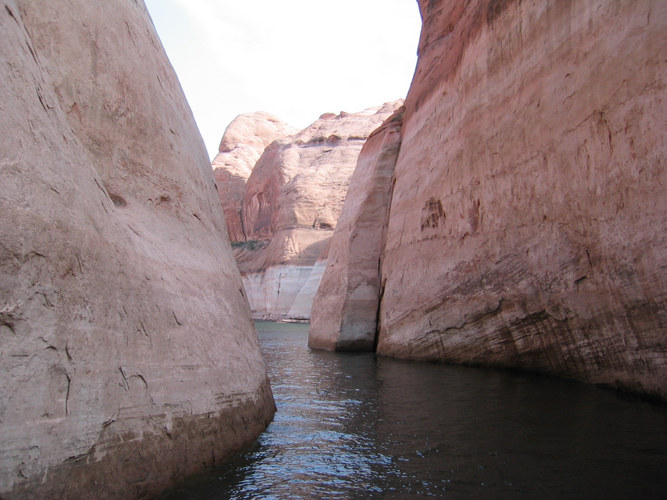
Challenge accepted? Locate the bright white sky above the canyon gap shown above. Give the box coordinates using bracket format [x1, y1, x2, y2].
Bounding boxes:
[145, 0, 421, 158]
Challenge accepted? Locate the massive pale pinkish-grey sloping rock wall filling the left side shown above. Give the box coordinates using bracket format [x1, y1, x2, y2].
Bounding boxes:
[0, 0, 275, 498]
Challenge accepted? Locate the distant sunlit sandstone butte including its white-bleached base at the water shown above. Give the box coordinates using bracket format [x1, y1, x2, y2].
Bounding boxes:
[235, 101, 402, 320]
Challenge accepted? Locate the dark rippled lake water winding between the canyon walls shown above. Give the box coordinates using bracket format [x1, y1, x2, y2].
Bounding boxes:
[161, 322, 667, 499]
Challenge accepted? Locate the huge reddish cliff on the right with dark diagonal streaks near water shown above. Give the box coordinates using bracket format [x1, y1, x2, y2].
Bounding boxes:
[314, 0, 667, 398]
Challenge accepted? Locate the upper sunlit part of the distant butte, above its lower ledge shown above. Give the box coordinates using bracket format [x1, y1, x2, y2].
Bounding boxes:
[243, 100, 403, 244]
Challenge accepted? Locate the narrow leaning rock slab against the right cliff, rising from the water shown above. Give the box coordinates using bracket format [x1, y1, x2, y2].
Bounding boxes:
[308, 108, 404, 351]
